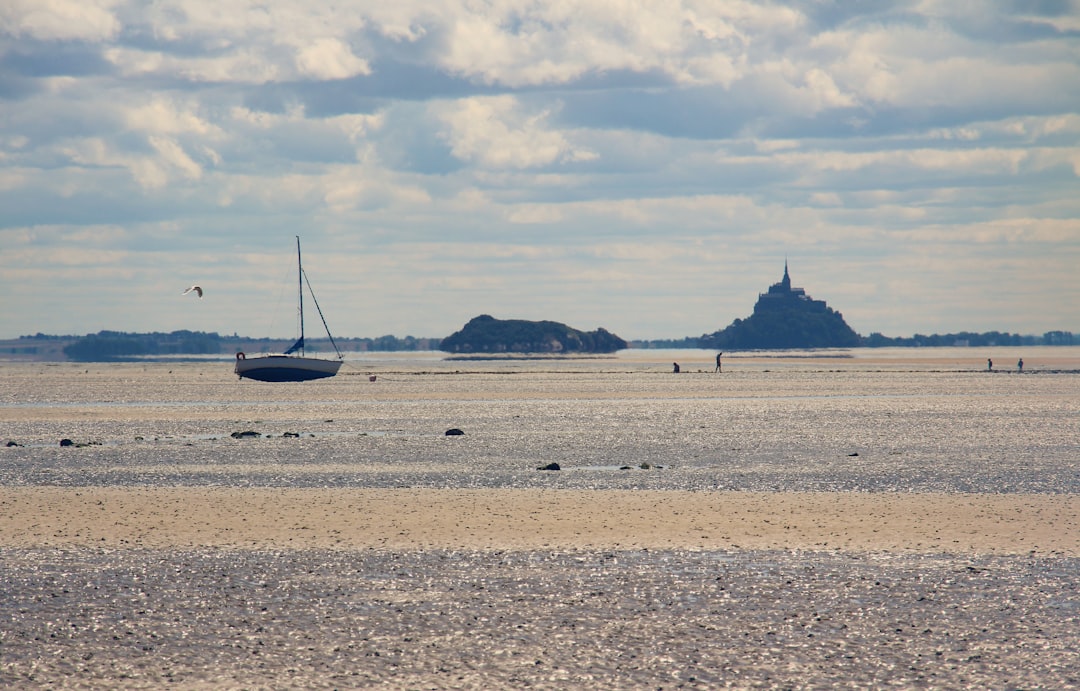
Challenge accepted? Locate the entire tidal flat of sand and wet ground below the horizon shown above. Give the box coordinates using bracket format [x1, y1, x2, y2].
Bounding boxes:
[0, 348, 1080, 689]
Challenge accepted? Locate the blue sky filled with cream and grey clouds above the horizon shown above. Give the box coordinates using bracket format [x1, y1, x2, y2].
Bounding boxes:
[0, 0, 1080, 339]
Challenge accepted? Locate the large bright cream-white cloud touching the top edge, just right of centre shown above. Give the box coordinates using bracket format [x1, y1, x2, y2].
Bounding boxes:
[427, 0, 802, 86]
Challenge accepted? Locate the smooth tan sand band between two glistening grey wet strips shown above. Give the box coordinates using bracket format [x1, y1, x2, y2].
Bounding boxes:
[0, 487, 1080, 556]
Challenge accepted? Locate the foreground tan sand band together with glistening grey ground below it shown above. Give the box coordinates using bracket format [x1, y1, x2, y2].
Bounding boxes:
[0, 487, 1080, 689]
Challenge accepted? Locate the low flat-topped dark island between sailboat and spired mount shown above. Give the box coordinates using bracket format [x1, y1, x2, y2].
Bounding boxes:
[438, 314, 626, 353]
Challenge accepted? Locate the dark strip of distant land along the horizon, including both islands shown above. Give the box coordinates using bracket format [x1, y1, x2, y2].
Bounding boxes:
[6, 261, 1080, 363]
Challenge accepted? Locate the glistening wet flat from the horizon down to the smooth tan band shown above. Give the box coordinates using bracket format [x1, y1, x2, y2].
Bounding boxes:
[0, 348, 1080, 493]
